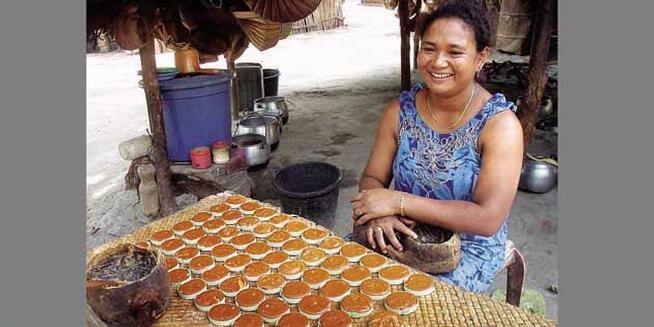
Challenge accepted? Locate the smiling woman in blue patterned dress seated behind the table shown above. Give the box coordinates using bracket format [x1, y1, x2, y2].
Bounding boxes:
[352, 1, 523, 292]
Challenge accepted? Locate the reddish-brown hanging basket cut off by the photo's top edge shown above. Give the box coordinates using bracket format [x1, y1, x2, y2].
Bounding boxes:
[245, 0, 320, 23]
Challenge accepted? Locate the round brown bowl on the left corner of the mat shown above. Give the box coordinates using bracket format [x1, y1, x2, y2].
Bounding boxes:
[86, 243, 171, 327]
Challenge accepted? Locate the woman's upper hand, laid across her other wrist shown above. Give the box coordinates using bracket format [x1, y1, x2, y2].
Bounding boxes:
[350, 188, 401, 225]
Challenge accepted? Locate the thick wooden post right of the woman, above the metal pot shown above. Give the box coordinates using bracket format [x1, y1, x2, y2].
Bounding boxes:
[518, 0, 554, 149]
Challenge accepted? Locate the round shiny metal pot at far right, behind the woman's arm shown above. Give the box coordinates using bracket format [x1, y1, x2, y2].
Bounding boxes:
[518, 154, 559, 193]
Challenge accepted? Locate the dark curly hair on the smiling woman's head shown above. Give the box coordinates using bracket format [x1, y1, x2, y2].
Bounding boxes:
[420, 1, 491, 51]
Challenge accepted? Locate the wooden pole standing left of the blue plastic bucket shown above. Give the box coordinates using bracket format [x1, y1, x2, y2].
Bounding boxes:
[138, 0, 177, 216]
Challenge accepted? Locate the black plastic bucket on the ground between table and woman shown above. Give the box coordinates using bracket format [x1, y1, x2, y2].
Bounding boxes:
[273, 161, 343, 229]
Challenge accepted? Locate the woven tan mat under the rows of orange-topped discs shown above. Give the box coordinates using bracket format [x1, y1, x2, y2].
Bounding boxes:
[87, 192, 556, 327]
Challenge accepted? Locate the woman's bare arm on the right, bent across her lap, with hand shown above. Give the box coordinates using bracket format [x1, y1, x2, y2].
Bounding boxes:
[355, 111, 523, 236]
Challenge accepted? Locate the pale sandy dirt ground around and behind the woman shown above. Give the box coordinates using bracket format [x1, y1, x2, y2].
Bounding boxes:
[86, 0, 558, 319]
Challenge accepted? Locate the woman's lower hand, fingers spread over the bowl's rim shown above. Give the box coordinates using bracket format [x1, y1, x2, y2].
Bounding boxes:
[366, 215, 418, 254]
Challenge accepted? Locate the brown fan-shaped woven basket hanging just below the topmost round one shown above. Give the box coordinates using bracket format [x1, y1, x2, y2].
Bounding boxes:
[232, 11, 288, 51]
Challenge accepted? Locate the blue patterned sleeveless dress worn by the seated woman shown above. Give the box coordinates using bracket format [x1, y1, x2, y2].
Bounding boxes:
[393, 84, 517, 293]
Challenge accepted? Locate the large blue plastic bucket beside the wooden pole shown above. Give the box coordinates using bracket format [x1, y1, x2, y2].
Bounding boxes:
[159, 73, 232, 162]
